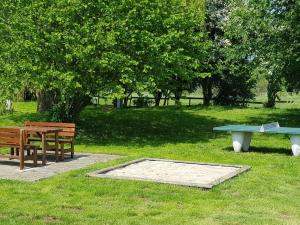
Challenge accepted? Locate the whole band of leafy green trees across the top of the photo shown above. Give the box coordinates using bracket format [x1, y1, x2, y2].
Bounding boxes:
[0, 0, 300, 121]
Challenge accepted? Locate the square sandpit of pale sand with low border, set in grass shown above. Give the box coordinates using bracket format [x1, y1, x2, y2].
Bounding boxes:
[88, 159, 250, 188]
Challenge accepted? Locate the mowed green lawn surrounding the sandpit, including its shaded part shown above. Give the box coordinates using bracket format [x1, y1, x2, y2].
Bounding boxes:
[0, 103, 300, 225]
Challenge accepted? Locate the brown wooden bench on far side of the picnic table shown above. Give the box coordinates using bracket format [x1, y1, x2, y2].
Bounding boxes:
[25, 122, 76, 161]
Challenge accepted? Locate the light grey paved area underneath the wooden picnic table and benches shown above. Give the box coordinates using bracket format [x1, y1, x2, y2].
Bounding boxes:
[0, 153, 121, 181]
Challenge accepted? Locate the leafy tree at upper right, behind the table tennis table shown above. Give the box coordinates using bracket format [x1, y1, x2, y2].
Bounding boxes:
[227, 0, 299, 107]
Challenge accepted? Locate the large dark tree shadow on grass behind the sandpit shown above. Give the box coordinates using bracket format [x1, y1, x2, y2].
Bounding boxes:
[77, 107, 228, 146]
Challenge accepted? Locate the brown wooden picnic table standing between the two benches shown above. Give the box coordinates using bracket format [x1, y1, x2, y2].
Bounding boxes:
[2, 127, 63, 165]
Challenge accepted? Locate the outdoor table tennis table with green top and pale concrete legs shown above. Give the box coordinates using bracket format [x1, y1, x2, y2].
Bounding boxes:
[213, 122, 300, 156]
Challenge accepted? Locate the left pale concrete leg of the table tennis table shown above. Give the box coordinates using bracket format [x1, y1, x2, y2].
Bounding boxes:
[232, 132, 252, 152]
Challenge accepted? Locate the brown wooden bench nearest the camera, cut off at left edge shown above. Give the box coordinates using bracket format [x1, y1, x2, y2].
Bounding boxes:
[0, 128, 37, 170]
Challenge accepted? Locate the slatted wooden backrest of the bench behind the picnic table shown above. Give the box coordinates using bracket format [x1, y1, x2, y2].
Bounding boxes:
[25, 122, 76, 139]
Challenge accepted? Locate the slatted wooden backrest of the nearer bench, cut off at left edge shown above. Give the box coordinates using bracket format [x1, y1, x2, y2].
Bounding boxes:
[0, 128, 24, 147]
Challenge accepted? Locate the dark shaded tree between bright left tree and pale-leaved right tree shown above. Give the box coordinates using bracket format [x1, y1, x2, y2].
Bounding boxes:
[199, 0, 255, 105]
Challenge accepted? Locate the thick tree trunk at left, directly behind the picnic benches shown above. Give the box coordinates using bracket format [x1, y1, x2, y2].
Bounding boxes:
[36, 91, 57, 112]
